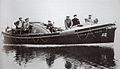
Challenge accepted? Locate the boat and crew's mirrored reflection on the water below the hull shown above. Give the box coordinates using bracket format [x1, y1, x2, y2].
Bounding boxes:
[4, 46, 115, 69]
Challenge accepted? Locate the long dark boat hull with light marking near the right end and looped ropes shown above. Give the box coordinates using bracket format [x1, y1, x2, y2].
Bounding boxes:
[2, 24, 116, 44]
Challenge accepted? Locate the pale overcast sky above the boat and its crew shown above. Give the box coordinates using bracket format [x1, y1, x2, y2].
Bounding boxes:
[0, 0, 120, 27]
